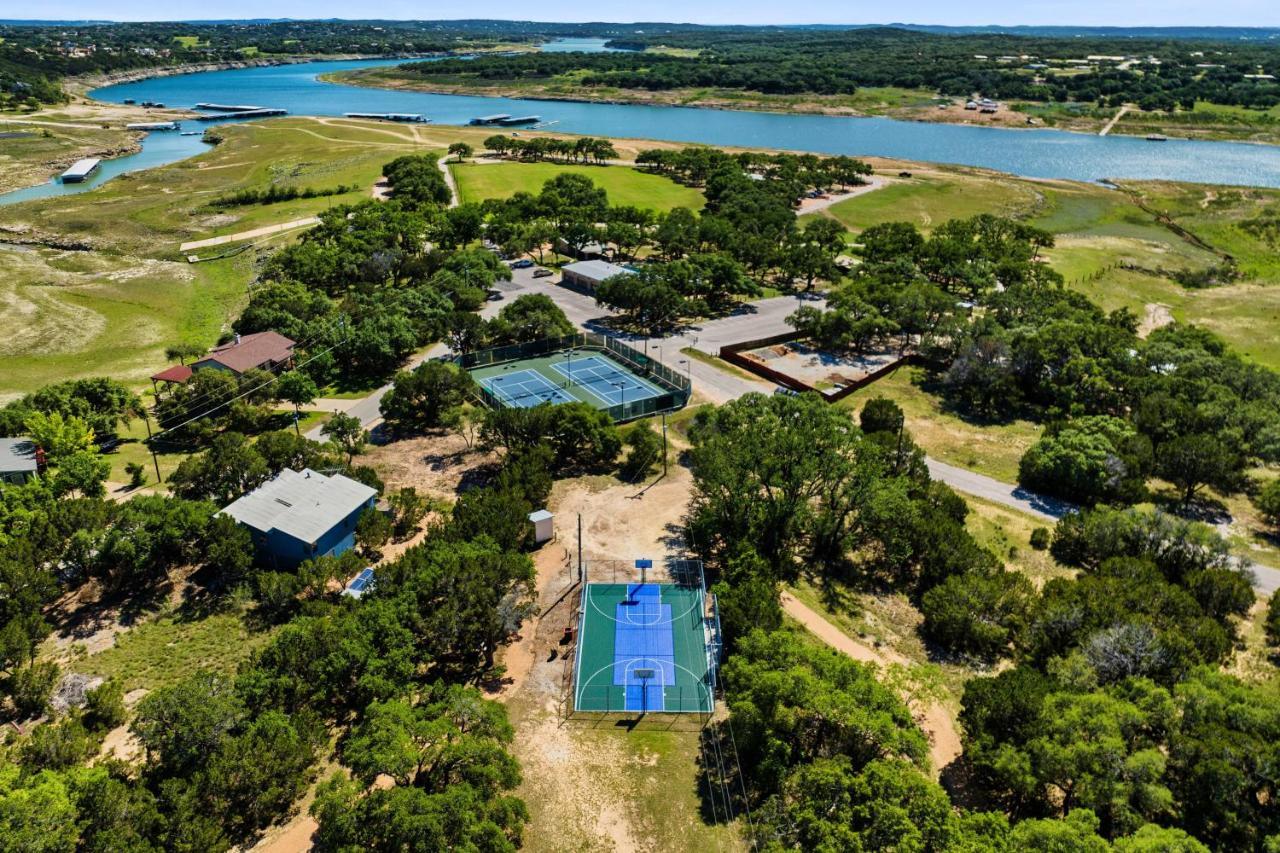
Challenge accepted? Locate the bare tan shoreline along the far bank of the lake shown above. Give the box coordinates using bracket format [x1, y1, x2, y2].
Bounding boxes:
[317, 69, 1280, 146]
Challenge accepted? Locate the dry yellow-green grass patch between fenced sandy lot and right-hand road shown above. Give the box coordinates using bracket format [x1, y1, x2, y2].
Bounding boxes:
[840, 368, 1041, 483]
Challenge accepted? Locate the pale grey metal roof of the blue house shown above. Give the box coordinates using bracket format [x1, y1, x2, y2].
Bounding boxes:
[219, 467, 378, 544]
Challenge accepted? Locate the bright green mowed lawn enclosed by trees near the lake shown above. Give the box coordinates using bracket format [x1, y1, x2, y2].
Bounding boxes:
[451, 163, 703, 211]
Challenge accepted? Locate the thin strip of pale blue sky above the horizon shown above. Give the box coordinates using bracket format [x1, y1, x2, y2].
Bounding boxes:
[15, 0, 1280, 27]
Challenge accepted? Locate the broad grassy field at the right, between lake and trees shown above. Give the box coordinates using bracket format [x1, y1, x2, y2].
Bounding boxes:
[815, 167, 1280, 369]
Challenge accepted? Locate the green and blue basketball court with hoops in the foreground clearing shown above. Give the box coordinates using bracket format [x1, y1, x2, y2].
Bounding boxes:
[573, 583, 714, 713]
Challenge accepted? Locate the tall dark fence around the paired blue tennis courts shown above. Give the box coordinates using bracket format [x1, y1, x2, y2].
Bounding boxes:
[452, 332, 692, 423]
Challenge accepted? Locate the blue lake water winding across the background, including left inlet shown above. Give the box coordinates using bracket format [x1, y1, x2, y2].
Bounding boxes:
[12, 34, 1280, 204]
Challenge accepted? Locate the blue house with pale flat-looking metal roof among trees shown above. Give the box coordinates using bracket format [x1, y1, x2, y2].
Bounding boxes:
[219, 467, 378, 569]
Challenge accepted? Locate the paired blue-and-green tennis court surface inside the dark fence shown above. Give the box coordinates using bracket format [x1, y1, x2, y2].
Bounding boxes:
[471, 350, 666, 409]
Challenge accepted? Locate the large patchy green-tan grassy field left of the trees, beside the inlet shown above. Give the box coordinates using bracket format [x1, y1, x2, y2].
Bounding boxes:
[0, 119, 483, 401]
